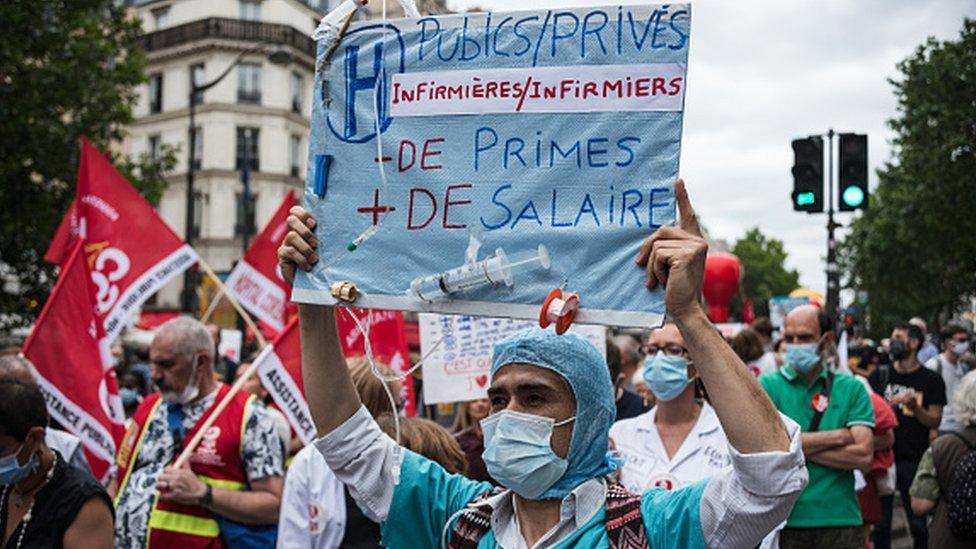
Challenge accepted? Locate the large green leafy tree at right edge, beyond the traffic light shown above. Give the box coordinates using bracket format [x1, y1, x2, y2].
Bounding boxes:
[840, 19, 976, 335]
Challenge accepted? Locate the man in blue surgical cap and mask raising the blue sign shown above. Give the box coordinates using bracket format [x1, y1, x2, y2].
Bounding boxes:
[278, 180, 807, 548]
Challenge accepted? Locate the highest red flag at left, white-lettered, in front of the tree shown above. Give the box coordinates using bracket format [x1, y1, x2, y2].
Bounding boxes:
[44, 139, 197, 341]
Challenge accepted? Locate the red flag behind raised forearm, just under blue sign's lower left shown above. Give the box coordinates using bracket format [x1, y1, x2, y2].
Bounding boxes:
[336, 308, 417, 417]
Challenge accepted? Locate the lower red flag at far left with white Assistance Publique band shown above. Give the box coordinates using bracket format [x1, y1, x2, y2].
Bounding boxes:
[21, 243, 125, 482]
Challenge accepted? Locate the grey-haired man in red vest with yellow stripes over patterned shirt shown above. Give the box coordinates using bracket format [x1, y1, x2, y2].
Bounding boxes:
[115, 317, 284, 547]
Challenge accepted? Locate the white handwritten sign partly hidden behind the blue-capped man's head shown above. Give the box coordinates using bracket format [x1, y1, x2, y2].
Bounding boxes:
[420, 313, 607, 404]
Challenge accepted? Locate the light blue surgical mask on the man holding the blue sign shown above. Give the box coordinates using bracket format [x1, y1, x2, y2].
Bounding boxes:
[481, 410, 576, 499]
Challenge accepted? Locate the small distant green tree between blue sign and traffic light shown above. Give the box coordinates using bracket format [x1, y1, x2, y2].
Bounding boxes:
[731, 228, 800, 318]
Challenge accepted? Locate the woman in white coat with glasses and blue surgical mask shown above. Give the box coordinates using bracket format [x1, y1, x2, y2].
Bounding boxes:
[610, 324, 732, 493]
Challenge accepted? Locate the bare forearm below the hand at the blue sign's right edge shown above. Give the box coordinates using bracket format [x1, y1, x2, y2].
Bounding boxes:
[674, 307, 790, 454]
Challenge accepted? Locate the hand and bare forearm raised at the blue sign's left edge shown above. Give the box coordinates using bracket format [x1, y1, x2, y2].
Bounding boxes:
[278, 206, 361, 437]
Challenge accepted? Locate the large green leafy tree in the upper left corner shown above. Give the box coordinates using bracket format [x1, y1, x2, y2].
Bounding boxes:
[0, 0, 175, 327]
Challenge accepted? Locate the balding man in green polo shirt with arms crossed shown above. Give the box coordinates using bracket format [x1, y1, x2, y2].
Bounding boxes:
[759, 305, 874, 549]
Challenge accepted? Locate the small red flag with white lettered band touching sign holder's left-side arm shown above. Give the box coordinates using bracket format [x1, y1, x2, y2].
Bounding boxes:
[254, 317, 315, 444]
